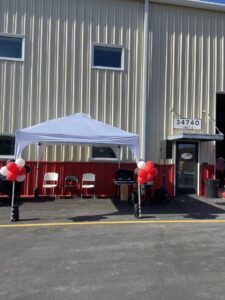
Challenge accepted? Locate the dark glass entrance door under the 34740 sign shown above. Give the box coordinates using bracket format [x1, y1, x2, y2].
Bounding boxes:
[176, 142, 198, 194]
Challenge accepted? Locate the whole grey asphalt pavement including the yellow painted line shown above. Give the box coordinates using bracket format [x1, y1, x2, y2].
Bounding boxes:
[0, 195, 225, 300]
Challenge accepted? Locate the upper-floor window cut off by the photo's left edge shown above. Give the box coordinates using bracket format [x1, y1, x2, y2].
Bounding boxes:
[0, 35, 24, 60]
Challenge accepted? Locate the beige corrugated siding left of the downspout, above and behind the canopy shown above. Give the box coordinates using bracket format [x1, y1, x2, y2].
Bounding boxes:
[0, 0, 143, 161]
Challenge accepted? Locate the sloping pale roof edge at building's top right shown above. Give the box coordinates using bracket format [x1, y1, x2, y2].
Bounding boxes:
[150, 0, 225, 12]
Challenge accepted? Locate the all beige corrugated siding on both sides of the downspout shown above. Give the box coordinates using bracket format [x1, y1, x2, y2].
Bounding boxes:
[0, 0, 225, 166]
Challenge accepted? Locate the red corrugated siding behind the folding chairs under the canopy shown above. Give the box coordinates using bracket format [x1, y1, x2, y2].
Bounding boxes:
[0, 161, 136, 196]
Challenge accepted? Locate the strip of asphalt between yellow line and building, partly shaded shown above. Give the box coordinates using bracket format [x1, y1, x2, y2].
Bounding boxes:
[0, 195, 225, 222]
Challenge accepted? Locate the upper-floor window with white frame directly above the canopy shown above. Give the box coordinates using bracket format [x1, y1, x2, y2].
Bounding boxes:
[92, 45, 124, 70]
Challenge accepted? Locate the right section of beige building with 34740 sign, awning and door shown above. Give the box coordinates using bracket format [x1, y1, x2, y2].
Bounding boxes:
[146, 0, 225, 193]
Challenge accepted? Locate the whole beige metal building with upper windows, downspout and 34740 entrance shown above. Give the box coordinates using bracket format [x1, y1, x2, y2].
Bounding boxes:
[0, 0, 225, 194]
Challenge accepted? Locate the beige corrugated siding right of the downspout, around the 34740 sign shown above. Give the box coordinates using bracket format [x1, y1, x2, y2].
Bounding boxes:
[146, 3, 225, 161]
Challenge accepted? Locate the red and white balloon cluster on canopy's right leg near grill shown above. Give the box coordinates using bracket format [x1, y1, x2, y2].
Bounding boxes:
[137, 160, 158, 184]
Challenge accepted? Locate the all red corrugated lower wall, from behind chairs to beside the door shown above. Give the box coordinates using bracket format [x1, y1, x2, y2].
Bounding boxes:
[1, 161, 174, 197]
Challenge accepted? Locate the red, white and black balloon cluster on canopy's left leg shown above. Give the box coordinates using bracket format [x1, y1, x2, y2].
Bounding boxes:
[0, 158, 27, 182]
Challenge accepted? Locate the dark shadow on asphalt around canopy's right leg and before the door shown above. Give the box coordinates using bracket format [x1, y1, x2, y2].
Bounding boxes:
[69, 195, 225, 222]
